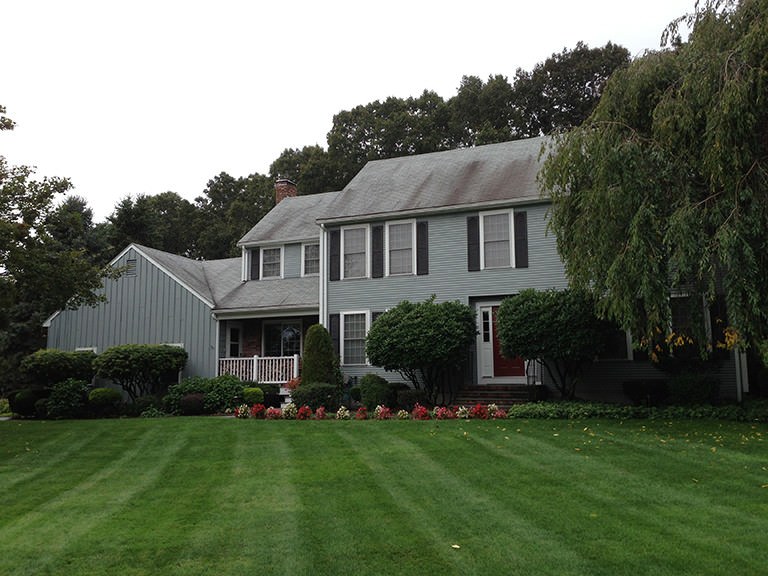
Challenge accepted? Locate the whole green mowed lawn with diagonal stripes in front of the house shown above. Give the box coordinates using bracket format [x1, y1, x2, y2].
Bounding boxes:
[0, 418, 768, 576]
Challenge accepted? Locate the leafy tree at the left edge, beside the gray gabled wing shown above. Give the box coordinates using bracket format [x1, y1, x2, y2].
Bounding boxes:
[0, 107, 116, 388]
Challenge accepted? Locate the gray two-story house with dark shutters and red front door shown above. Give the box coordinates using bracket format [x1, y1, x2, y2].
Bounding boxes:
[46, 138, 747, 400]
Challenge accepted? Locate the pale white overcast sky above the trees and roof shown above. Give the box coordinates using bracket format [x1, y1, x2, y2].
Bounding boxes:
[0, 0, 695, 220]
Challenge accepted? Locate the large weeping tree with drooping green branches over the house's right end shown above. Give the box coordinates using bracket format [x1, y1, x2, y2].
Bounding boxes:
[540, 0, 768, 358]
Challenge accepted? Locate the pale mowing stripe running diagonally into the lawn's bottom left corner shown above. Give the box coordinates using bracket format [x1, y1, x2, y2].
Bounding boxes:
[0, 418, 190, 574]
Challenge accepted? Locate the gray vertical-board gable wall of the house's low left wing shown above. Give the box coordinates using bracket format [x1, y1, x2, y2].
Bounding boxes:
[48, 249, 216, 377]
